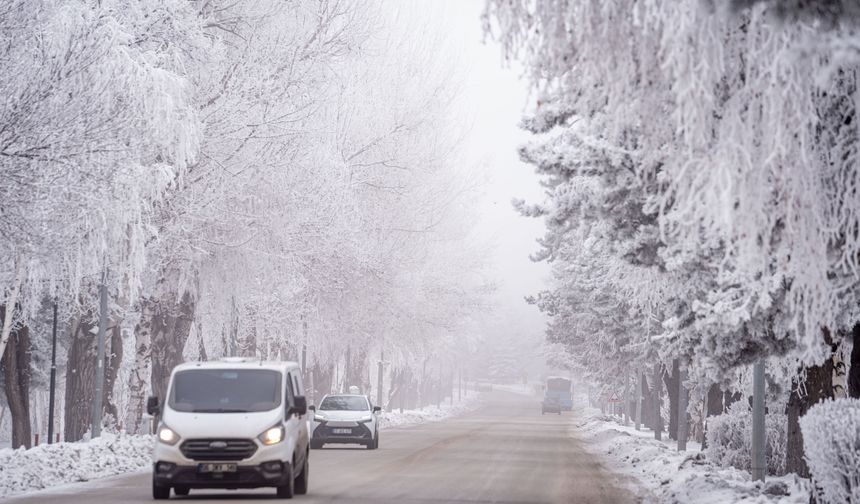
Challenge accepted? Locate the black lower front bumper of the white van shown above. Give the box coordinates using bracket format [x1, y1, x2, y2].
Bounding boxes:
[152, 460, 292, 489]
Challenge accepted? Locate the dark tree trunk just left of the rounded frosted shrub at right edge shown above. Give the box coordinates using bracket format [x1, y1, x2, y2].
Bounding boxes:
[785, 330, 833, 478]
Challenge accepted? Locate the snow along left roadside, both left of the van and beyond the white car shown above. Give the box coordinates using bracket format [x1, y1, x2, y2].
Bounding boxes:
[0, 392, 480, 498]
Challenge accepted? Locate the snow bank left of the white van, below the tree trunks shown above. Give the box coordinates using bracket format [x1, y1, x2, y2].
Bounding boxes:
[0, 433, 153, 498]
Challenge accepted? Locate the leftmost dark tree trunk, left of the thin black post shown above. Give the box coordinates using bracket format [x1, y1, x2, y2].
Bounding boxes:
[0, 306, 32, 448]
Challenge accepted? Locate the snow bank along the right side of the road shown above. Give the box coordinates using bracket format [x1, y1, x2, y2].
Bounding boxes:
[575, 408, 810, 504]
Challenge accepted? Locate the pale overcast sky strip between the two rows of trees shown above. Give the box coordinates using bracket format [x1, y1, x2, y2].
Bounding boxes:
[399, 0, 549, 350]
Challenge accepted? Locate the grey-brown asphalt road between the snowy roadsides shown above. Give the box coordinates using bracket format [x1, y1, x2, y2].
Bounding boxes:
[6, 392, 637, 504]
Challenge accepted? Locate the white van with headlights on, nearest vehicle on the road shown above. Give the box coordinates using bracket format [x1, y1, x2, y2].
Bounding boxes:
[147, 358, 309, 499]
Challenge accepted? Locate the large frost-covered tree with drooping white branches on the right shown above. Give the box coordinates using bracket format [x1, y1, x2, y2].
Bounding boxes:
[486, 0, 860, 460]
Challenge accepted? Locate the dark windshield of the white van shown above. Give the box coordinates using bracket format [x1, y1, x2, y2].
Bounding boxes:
[168, 369, 281, 413]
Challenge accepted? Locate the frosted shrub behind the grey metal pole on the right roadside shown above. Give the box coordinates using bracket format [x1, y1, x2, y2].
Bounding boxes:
[705, 402, 788, 474]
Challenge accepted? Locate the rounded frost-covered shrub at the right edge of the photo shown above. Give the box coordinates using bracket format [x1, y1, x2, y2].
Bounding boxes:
[800, 399, 860, 503]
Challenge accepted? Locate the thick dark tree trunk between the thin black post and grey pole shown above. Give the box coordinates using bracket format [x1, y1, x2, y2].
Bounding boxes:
[64, 318, 98, 441]
